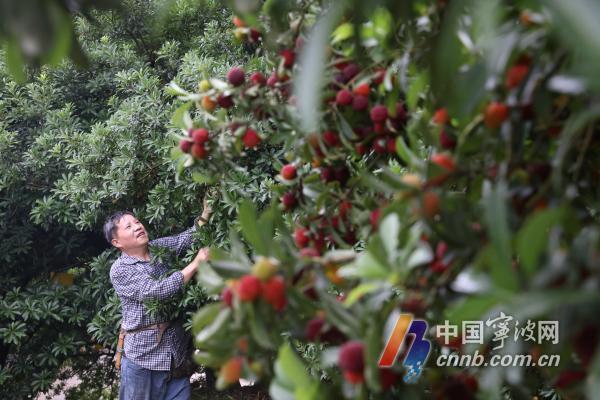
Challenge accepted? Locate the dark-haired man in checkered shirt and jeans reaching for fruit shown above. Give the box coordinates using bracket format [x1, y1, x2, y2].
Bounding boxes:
[104, 201, 211, 400]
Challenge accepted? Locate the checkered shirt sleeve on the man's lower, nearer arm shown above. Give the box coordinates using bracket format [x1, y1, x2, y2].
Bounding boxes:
[110, 265, 183, 302]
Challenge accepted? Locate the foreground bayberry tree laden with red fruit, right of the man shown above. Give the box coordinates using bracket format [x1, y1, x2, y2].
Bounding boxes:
[164, 0, 600, 399]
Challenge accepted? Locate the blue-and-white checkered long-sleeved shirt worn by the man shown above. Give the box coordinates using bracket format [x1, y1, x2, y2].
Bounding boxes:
[110, 224, 196, 371]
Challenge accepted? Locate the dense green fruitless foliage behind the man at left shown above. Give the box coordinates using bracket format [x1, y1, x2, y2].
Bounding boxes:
[0, 1, 266, 399]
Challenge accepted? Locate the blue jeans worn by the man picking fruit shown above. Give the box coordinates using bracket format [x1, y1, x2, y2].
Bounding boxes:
[119, 357, 191, 400]
